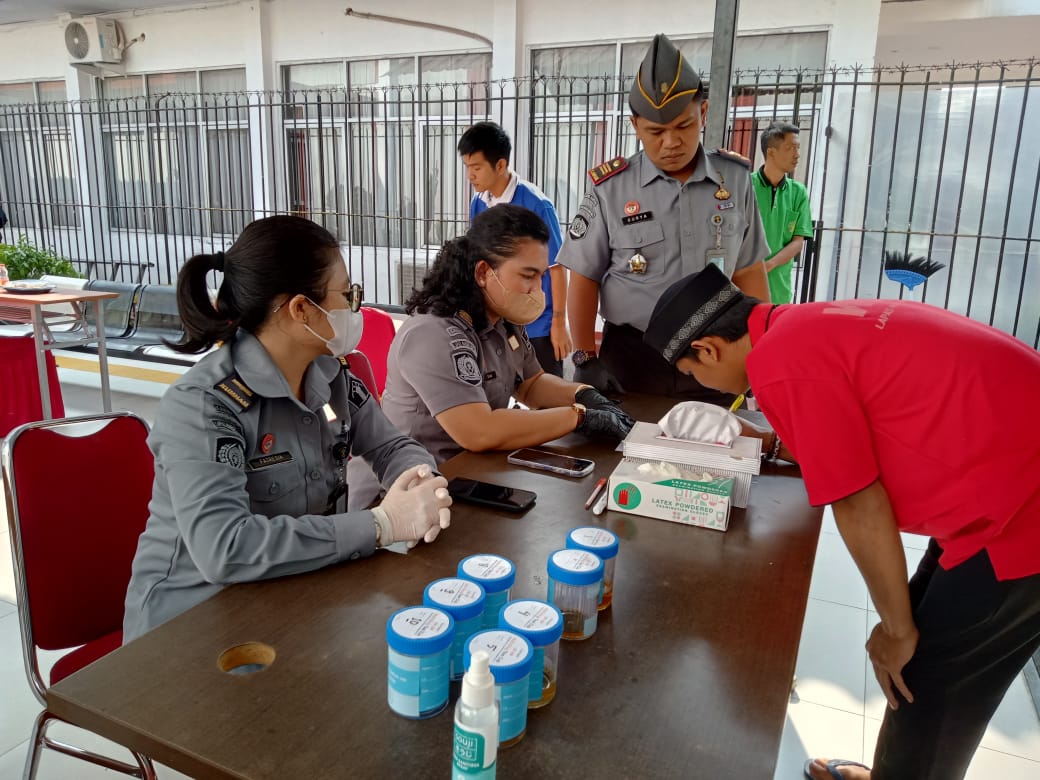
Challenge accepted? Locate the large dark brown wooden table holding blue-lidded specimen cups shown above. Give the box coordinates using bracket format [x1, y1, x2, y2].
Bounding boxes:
[47, 398, 821, 780]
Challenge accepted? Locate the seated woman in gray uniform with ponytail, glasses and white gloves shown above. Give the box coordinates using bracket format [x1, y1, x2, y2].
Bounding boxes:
[123, 216, 451, 642]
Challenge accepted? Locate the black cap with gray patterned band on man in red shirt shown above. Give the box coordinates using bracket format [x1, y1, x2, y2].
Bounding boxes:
[643, 265, 744, 365]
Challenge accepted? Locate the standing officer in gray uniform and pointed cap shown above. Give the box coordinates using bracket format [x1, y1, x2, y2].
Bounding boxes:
[556, 34, 770, 402]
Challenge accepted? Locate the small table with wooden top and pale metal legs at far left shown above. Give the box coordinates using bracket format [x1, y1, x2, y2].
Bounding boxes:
[0, 288, 119, 420]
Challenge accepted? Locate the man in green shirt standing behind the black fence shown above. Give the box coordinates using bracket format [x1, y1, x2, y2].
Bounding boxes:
[751, 122, 812, 304]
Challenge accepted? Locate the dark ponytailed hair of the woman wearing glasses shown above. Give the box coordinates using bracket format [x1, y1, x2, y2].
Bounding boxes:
[170, 215, 339, 353]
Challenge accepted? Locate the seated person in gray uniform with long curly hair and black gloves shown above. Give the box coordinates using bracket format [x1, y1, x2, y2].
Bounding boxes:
[383, 204, 633, 463]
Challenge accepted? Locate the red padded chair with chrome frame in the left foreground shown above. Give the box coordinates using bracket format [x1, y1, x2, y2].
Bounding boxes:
[2, 412, 155, 780]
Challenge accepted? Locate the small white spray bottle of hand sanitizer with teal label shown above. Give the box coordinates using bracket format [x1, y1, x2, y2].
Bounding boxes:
[451, 650, 498, 780]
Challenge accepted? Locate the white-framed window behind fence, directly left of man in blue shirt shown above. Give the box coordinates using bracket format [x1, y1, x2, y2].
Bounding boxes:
[283, 53, 491, 248]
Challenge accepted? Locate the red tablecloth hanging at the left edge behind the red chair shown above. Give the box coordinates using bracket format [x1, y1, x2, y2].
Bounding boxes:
[0, 337, 64, 436]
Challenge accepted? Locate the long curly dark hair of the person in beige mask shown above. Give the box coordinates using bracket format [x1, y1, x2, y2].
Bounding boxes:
[405, 204, 549, 330]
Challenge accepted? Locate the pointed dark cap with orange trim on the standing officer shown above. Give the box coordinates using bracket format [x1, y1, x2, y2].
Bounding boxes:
[628, 33, 701, 125]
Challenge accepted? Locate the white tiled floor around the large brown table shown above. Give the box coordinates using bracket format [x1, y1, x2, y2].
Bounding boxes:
[0, 372, 1040, 780]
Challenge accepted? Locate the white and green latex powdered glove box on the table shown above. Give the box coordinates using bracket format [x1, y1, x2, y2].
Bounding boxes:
[606, 458, 734, 530]
